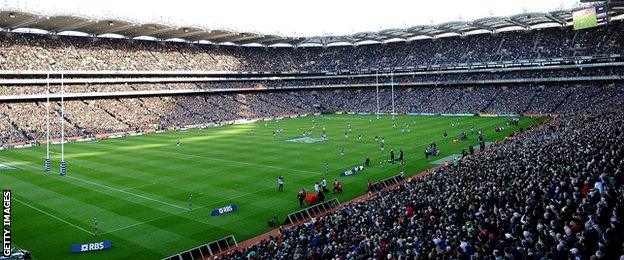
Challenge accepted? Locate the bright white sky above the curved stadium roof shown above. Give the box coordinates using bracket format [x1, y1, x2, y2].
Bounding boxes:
[0, 0, 579, 37]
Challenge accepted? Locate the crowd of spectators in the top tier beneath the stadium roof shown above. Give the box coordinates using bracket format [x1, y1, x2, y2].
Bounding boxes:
[0, 20, 624, 71]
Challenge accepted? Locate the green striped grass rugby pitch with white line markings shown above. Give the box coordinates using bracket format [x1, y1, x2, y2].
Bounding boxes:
[0, 115, 541, 259]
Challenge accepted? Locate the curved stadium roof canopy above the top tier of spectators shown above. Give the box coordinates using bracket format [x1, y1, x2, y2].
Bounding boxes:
[0, 9, 624, 46]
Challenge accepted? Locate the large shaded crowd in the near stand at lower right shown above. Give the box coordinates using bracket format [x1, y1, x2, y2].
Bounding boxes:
[219, 82, 624, 259]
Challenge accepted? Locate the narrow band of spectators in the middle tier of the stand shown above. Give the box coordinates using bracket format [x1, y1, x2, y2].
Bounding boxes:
[0, 66, 624, 99]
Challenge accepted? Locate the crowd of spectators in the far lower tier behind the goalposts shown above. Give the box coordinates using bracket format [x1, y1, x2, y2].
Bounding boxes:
[0, 83, 624, 145]
